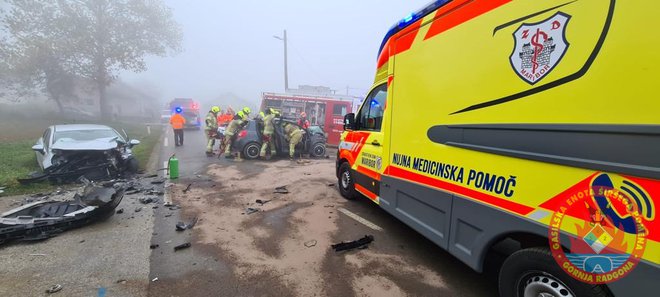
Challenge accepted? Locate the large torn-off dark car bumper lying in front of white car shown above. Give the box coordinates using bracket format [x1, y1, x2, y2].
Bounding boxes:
[0, 181, 125, 244]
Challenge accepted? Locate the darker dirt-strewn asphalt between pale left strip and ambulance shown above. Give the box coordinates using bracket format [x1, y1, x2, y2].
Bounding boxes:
[149, 127, 497, 296]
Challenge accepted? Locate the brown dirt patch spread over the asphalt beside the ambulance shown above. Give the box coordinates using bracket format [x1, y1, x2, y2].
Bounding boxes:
[160, 159, 456, 296]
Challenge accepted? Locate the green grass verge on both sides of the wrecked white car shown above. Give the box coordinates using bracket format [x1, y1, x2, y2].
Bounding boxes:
[0, 123, 162, 196]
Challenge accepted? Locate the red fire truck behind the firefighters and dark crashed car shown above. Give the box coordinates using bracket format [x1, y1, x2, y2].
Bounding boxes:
[261, 93, 353, 146]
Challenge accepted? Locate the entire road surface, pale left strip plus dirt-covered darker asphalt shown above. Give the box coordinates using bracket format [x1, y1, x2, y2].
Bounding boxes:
[0, 129, 497, 297]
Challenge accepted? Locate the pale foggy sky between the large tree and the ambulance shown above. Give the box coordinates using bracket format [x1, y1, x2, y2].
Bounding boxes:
[121, 0, 429, 104]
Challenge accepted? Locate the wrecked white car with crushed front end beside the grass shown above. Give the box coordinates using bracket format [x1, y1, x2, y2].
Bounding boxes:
[19, 125, 140, 183]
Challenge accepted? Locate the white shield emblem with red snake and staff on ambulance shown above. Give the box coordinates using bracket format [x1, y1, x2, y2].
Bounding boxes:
[509, 12, 571, 85]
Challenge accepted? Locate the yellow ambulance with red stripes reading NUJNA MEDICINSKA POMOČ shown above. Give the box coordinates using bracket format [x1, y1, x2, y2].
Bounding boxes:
[336, 0, 660, 297]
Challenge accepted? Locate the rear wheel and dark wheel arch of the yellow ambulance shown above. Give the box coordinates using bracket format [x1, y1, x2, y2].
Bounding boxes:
[499, 247, 611, 297]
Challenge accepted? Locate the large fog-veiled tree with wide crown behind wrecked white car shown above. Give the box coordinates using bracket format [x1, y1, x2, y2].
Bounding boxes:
[3, 0, 182, 119]
